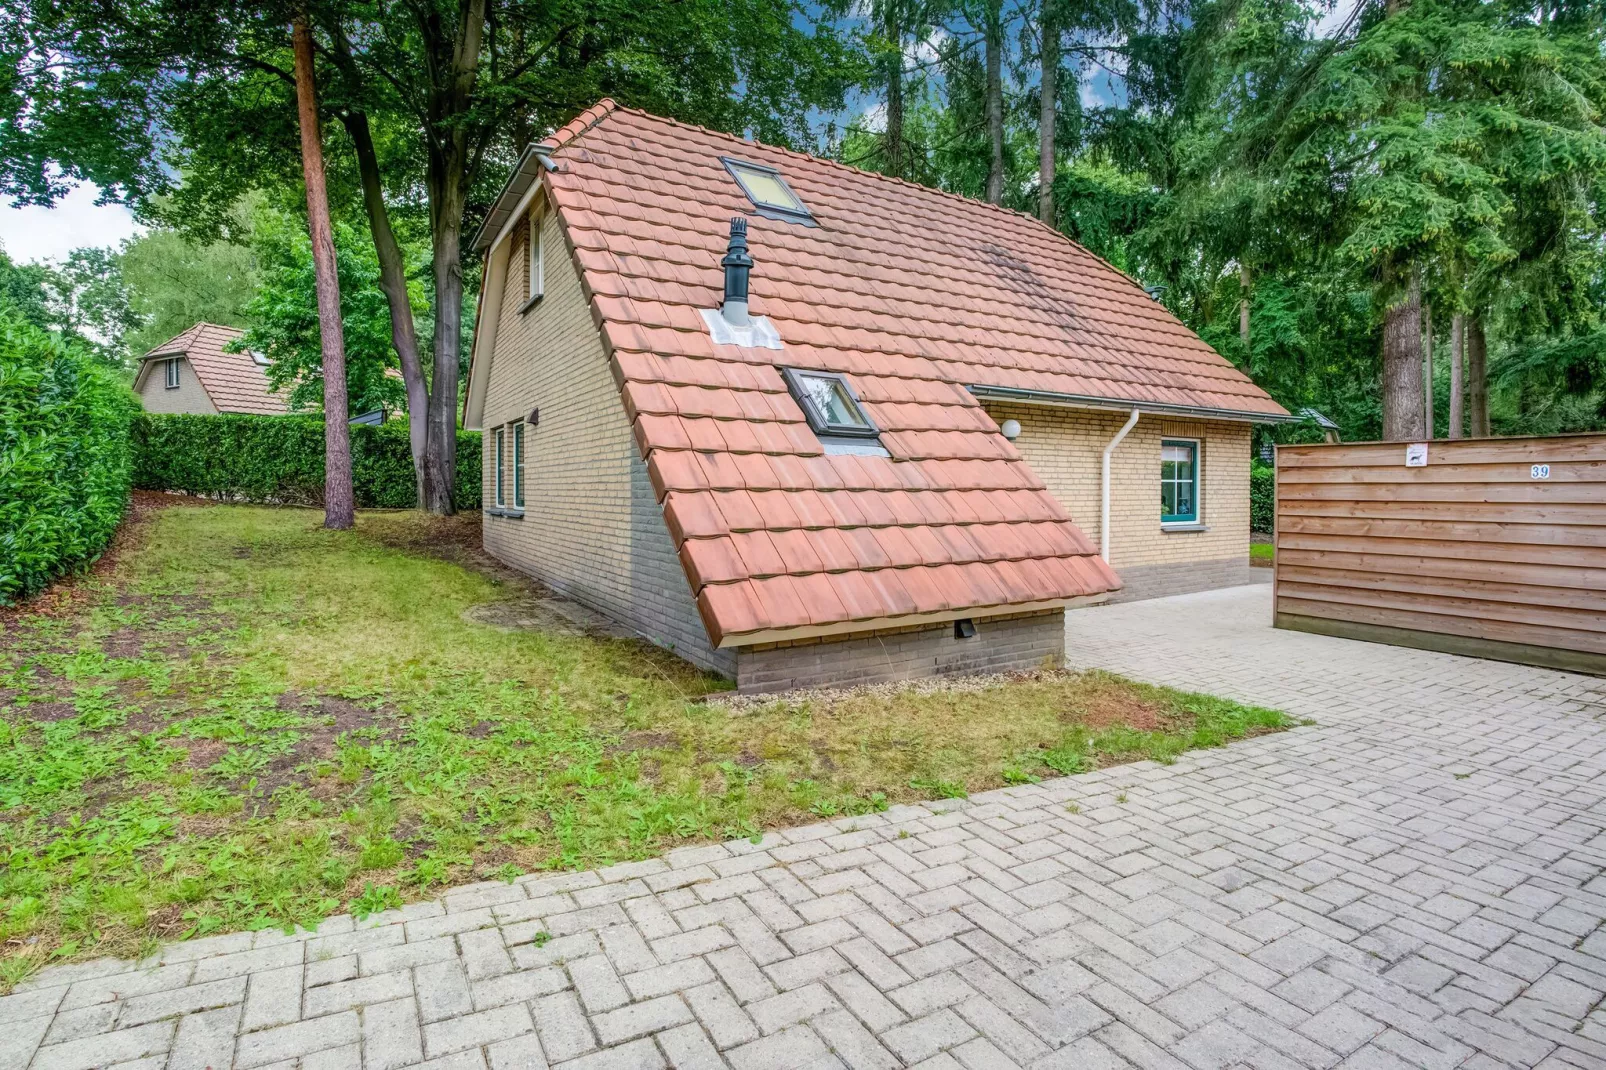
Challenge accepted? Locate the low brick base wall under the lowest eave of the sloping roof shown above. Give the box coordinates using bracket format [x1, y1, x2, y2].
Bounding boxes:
[736, 609, 1065, 692]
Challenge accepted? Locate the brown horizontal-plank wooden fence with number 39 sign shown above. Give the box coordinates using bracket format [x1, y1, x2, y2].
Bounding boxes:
[1275, 434, 1606, 673]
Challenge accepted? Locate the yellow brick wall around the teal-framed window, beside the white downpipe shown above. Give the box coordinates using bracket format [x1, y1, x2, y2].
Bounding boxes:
[986, 402, 1249, 570]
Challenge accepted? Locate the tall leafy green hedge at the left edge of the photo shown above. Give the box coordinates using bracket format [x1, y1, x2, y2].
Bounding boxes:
[0, 317, 138, 604]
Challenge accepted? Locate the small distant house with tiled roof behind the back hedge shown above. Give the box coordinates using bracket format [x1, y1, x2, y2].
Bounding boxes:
[133, 323, 289, 416]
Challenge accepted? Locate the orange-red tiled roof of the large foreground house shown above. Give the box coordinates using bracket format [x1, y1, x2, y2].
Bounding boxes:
[466, 101, 1285, 646]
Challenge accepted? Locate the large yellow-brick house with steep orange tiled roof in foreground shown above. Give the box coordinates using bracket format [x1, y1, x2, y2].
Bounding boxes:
[464, 101, 1288, 691]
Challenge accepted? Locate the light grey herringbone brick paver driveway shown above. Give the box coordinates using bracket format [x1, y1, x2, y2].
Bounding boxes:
[9, 586, 1606, 1070]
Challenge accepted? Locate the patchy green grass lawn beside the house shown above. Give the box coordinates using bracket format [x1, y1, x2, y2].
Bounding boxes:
[0, 506, 1286, 986]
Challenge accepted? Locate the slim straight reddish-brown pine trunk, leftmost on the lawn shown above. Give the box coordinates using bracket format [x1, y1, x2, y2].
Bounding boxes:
[292, 13, 357, 530]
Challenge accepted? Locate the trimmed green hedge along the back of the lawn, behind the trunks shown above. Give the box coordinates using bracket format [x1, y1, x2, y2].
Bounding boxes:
[133, 413, 480, 509]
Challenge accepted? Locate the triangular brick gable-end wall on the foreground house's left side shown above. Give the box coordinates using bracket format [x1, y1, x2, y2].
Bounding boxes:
[482, 197, 736, 675]
